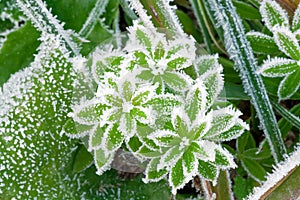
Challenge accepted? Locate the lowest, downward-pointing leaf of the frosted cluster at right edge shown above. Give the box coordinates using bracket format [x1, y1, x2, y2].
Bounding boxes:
[278, 69, 300, 99]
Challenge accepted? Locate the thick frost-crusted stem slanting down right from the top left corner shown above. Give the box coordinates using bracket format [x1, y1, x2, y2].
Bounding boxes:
[17, 0, 80, 56]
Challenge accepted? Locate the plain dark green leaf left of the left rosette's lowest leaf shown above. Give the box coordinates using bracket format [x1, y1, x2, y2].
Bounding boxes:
[73, 145, 94, 173]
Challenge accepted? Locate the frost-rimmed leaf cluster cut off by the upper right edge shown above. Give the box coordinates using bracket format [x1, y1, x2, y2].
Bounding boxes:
[247, 0, 300, 99]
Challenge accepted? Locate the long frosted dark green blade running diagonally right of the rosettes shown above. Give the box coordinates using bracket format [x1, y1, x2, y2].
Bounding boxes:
[208, 0, 286, 162]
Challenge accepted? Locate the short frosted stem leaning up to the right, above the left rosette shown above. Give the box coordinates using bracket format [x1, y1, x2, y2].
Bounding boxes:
[79, 0, 108, 38]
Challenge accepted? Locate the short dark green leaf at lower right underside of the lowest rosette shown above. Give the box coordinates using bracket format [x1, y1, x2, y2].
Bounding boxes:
[198, 160, 218, 181]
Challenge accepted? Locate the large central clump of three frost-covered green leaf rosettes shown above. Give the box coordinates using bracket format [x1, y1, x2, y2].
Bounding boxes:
[65, 21, 248, 194]
